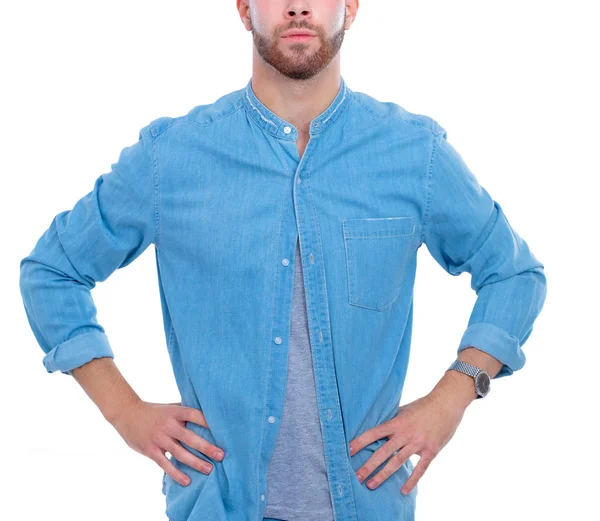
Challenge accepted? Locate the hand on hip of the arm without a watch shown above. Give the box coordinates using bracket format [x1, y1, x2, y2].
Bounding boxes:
[111, 400, 224, 486]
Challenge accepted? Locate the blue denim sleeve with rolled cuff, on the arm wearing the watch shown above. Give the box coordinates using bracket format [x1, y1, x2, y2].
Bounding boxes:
[421, 127, 546, 378]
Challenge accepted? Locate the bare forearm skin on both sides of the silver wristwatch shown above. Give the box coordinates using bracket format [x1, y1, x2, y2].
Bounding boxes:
[432, 347, 503, 408]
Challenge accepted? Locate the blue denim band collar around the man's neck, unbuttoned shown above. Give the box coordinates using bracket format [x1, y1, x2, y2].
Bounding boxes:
[242, 76, 352, 141]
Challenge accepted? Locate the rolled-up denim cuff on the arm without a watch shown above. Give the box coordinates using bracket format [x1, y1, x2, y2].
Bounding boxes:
[42, 331, 114, 375]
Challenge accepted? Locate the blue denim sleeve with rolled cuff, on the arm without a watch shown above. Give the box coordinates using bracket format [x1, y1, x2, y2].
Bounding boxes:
[19, 125, 156, 375]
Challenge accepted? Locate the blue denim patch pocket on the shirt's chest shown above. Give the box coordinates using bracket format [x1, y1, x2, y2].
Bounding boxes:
[342, 216, 415, 311]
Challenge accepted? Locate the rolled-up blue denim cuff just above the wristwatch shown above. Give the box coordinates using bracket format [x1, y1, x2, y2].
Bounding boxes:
[457, 322, 525, 378]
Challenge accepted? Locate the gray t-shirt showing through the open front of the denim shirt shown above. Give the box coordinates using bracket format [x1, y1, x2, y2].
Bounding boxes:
[264, 241, 333, 521]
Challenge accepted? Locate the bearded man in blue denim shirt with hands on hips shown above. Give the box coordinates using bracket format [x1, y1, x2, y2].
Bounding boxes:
[20, 0, 546, 521]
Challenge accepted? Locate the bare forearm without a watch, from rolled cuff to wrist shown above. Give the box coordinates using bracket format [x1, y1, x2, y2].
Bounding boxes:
[71, 357, 140, 424]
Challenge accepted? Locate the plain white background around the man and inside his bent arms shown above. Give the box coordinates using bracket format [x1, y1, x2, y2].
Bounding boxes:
[0, 0, 600, 521]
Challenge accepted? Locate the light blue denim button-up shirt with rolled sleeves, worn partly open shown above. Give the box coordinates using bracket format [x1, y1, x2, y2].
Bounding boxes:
[20, 77, 546, 521]
